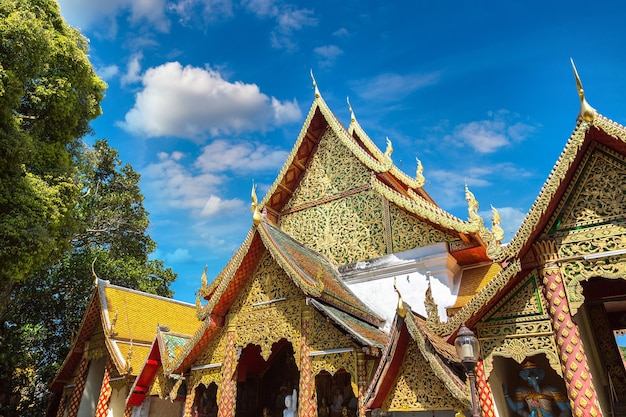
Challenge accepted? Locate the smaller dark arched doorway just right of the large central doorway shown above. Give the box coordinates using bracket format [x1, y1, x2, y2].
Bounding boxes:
[315, 369, 358, 417]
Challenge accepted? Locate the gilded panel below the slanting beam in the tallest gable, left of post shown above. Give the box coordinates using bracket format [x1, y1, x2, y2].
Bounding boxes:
[281, 189, 387, 264]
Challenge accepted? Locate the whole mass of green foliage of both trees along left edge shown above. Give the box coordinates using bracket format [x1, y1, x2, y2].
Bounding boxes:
[0, 0, 176, 416]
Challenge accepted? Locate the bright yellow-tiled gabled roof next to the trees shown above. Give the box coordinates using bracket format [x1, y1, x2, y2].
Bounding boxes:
[51, 279, 200, 391]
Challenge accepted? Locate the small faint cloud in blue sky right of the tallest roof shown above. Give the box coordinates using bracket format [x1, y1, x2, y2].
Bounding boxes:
[454, 110, 536, 153]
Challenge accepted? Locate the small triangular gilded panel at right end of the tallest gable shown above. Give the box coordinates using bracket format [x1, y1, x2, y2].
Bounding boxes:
[389, 203, 458, 252]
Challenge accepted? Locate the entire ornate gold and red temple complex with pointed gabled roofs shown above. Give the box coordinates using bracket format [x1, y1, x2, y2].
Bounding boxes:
[49, 68, 626, 417]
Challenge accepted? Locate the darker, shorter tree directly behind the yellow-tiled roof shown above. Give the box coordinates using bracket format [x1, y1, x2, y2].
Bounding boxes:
[0, 140, 176, 416]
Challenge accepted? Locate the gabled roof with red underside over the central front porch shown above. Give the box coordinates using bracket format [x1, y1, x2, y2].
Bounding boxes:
[171, 218, 384, 373]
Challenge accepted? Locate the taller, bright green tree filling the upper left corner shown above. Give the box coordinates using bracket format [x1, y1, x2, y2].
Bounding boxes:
[0, 0, 106, 308]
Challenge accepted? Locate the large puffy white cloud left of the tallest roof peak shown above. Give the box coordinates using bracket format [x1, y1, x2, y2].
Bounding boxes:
[120, 62, 301, 140]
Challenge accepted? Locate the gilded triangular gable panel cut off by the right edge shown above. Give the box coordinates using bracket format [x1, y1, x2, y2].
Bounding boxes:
[553, 147, 626, 232]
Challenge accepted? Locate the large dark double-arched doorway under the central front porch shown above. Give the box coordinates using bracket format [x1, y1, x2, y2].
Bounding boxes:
[235, 339, 300, 417]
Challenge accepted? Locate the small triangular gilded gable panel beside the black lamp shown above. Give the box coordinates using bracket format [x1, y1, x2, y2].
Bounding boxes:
[382, 340, 465, 412]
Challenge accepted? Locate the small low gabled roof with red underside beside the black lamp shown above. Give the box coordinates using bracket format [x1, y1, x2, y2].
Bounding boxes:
[364, 303, 470, 409]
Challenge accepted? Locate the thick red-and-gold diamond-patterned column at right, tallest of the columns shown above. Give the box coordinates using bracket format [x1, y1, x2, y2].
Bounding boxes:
[533, 240, 602, 417]
